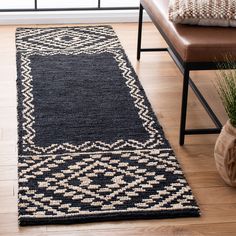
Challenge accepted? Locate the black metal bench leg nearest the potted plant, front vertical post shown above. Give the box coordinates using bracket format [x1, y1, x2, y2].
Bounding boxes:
[179, 69, 189, 146]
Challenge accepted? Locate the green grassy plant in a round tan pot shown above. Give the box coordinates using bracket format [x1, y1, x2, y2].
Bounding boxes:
[214, 60, 236, 187]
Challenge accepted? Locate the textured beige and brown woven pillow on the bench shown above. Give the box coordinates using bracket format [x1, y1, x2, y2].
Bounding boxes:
[168, 0, 236, 27]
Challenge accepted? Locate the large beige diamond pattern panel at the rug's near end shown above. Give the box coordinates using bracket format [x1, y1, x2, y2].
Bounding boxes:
[19, 150, 198, 216]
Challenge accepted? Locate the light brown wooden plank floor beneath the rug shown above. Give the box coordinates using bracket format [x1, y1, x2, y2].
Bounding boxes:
[0, 23, 236, 236]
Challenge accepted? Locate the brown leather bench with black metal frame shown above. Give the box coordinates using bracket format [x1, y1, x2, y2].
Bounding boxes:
[137, 0, 236, 146]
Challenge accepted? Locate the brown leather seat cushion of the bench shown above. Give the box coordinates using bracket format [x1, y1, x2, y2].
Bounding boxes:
[141, 0, 236, 62]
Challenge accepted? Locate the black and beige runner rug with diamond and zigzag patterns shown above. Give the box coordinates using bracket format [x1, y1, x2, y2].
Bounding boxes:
[16, 26, 199, 225]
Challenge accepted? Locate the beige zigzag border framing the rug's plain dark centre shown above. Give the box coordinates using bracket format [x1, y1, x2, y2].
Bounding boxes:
[17, 27, 163, 154]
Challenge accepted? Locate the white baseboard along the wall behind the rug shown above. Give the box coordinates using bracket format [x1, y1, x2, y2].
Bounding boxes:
[0, 10, 150, 25]
